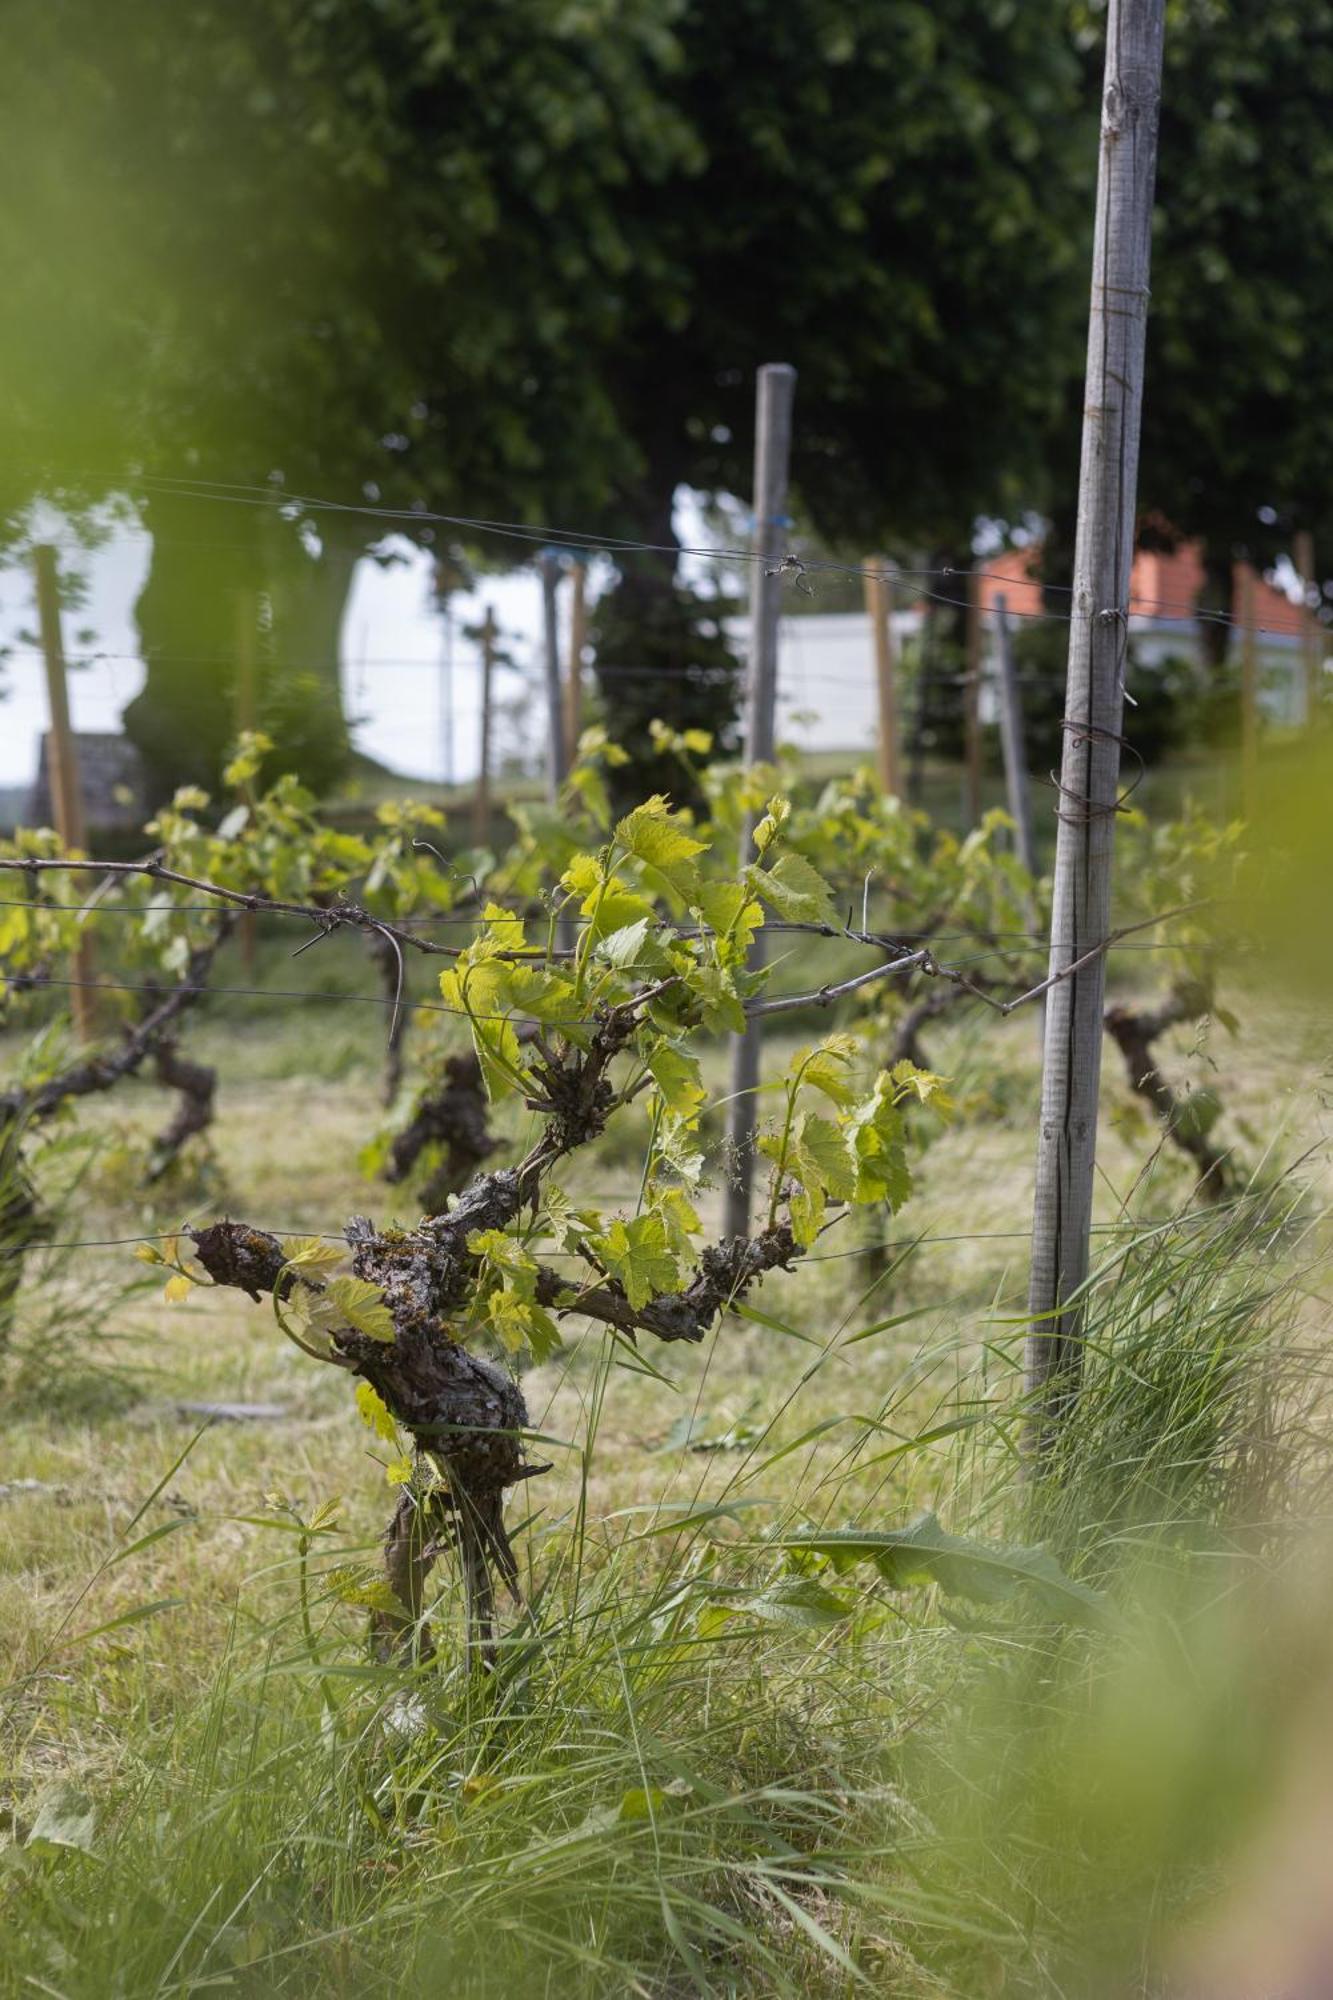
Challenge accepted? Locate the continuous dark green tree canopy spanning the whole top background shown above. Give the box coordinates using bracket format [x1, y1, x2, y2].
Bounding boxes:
[0, 0, 1333, 796]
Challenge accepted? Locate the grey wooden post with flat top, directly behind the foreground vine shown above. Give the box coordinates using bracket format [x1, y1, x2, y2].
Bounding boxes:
[727, 362, 797, 1236]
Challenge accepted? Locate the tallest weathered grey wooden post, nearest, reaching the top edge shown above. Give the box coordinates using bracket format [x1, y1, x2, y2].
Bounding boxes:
[1027, 0, 1165, 1450]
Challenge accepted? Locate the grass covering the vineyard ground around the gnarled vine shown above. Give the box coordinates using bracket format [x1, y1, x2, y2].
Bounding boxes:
[0, 928, 1329, 2000]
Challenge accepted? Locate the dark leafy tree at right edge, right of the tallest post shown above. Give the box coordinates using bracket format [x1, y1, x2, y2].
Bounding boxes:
[1047, 0, 1333, 648]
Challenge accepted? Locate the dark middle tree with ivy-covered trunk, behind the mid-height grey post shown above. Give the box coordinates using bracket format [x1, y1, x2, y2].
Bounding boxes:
[588, 0, 1095, 772]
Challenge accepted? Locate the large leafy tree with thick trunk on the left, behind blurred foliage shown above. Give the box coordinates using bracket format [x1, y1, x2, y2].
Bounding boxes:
[0, 0, 685, 792]
